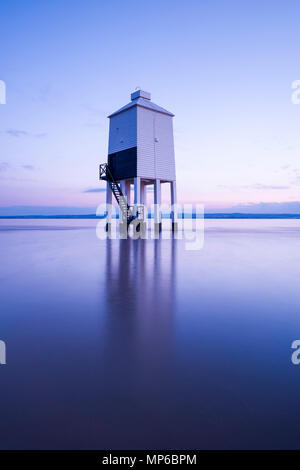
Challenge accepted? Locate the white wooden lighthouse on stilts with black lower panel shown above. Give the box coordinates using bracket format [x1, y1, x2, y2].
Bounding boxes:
[100, 90, 177, 231]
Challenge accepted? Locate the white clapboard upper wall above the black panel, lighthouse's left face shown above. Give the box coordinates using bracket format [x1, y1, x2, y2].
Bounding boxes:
[108, 107, 137, 154]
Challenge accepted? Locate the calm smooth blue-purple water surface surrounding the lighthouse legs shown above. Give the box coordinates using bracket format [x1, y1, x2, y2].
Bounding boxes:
[0, 220, 300, 449]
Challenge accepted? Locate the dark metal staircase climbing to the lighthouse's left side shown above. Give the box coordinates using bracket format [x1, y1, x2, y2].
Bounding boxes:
[99, 163, 143, 227]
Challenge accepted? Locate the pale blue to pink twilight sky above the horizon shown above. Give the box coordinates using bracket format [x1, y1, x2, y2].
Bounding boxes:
[0, 0, 300, 215]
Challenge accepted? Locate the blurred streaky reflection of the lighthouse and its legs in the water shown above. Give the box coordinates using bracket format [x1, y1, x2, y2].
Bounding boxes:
[105, 238, 176, 360]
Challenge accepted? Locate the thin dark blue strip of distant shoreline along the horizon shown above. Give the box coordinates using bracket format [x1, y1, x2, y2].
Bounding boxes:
[0, 213, 300, 219]
